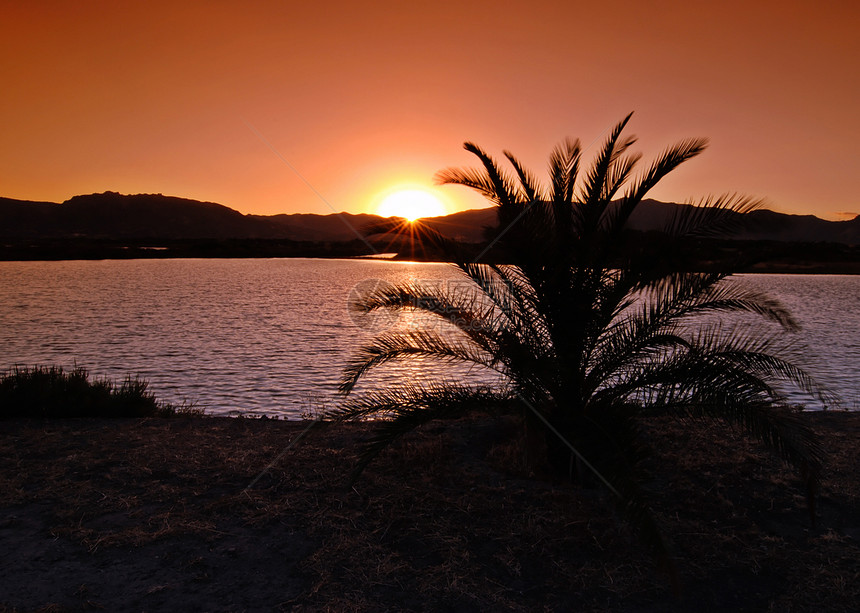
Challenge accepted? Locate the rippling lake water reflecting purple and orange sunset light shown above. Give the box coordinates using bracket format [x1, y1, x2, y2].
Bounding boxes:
[0, 259, 860, 417]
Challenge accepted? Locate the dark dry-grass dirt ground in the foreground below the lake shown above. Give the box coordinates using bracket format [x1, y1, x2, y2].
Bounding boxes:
[0, 413, 860, 612]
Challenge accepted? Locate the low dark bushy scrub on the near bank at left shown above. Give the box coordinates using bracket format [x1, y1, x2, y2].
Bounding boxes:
[0, 366, 202, 419]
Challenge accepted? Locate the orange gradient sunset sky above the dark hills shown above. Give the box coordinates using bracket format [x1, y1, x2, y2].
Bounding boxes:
[0, 0, 860, 219]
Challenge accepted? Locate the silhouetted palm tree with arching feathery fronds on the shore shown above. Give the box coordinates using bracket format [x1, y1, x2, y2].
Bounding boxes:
[330, 115, 829, 559]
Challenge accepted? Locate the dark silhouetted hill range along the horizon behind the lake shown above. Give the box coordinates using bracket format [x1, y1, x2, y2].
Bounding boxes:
[0, 192, 860, 245]
